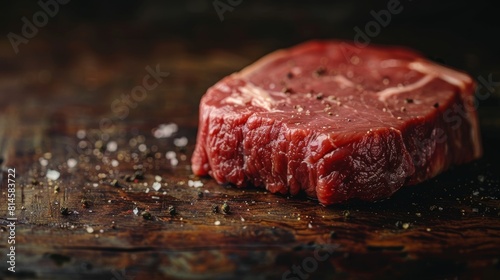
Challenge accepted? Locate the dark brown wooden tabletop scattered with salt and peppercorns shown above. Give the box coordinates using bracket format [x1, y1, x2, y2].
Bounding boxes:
[0, 19, 500, 279]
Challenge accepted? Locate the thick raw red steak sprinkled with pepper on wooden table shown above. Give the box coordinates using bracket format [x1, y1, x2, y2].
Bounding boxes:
[192, 41, 482, 205]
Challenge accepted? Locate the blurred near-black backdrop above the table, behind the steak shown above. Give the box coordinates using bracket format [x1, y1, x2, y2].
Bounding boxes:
[0, 0, 500, 71]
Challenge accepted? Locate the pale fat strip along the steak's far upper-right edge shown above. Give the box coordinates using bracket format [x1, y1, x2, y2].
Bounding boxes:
[408, 61, 472, 90]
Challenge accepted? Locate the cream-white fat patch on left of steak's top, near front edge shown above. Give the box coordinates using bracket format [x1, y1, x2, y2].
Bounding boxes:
[222, 83, 274, 111]
